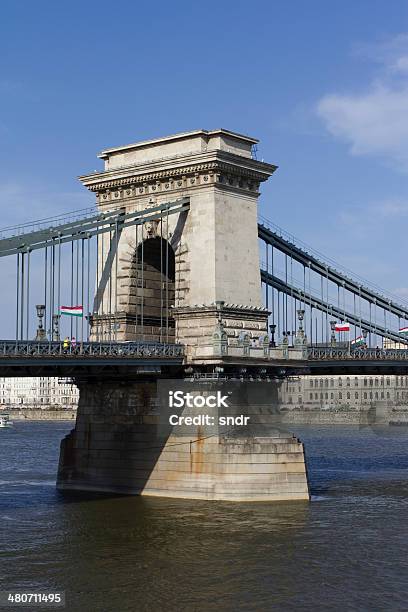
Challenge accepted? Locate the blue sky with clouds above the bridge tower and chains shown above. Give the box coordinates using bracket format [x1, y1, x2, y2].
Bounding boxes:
[0, 0, 408, 306]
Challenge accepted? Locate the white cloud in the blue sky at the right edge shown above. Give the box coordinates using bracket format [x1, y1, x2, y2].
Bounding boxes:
[317, 35, 408, 172]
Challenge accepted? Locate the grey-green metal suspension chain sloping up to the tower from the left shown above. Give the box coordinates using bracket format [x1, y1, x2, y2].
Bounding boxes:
[0, 197, 190, 257]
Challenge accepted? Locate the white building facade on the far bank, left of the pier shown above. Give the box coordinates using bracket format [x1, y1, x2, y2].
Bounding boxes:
[0, 377, 78, 410]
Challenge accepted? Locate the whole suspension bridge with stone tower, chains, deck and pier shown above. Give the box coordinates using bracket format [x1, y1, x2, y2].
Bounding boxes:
[0, 129, 408, 501]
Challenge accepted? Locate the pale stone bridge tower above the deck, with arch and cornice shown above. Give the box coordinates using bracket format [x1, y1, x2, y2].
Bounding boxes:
[80, 129, 276, 361]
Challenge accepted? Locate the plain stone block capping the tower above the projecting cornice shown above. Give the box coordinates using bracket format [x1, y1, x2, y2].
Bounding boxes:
[98, 129, 259, 160]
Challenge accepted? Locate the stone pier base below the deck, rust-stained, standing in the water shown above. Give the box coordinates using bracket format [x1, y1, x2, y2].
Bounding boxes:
[57, 381, 309, 501]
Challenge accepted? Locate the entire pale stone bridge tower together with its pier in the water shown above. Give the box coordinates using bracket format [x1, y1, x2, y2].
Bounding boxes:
[58, 129, 308, 500]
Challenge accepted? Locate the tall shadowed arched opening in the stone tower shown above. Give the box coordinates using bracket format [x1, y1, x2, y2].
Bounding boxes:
[134, 237, 175, 342]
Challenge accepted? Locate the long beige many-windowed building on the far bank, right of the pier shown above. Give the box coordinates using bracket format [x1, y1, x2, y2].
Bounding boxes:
[279, 375, 408, 410]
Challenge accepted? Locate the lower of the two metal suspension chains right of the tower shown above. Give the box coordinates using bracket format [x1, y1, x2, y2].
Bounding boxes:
[261, 270, 408, 344]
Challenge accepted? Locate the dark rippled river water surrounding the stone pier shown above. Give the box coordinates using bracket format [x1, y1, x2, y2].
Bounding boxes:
[0, 422, 408, 612]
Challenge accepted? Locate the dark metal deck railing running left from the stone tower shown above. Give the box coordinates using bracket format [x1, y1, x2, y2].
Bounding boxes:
[0, 340, 184, 358]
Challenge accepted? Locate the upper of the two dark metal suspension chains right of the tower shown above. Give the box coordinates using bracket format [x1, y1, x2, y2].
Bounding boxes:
[258, 223, 408, 320]
